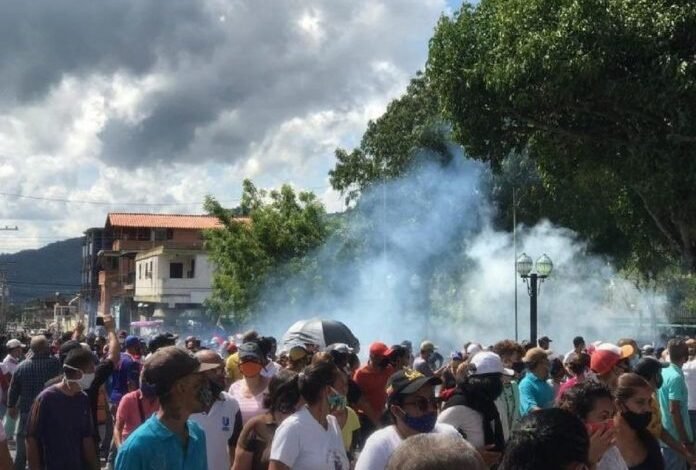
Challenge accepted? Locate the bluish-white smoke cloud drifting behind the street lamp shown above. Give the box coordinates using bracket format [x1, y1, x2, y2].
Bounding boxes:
[247, 152, 663, 353]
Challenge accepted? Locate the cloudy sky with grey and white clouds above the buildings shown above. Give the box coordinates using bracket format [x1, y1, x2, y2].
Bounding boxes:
[0, 0, 459, 252]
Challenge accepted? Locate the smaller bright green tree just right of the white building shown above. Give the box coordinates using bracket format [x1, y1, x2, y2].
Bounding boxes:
[205, 180, 330, 324]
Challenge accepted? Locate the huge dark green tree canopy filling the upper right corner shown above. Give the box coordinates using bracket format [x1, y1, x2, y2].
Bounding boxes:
[427, 0, 696, 271]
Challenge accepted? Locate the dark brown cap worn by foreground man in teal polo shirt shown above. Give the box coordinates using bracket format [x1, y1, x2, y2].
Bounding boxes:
[143, 346, 218, 396]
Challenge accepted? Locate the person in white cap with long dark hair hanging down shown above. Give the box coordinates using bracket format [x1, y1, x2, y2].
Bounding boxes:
[437, 351, 515, 467]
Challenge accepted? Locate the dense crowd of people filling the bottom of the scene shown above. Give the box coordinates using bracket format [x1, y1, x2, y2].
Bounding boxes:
[0, 316, 696, 470]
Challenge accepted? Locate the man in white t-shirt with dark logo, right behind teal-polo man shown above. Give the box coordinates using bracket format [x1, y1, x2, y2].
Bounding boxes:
[191, 349, 242, 470]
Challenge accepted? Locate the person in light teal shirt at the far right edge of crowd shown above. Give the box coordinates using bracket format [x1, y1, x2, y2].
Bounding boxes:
[657, 339, 694, 470]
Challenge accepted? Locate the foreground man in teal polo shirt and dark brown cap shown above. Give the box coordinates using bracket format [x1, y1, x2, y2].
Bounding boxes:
[116, 346, 217, 470]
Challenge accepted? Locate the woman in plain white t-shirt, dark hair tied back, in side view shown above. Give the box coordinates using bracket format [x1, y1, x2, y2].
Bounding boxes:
[268, 361, 350, 470]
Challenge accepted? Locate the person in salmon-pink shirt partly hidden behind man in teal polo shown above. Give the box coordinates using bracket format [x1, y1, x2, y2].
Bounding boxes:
[113, 375, 159, 450]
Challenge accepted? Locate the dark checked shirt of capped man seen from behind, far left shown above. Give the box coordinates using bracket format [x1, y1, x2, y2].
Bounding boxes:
[7, 353, 62, 413]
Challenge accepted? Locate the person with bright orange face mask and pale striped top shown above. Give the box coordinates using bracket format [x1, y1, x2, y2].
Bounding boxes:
[229, 342, 271, 424]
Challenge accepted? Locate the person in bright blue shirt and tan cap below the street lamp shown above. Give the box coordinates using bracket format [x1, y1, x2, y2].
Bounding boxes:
[519, 348, 553, 416]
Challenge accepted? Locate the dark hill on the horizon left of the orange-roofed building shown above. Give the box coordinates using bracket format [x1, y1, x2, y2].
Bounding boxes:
[0, 237, 82, 304]
